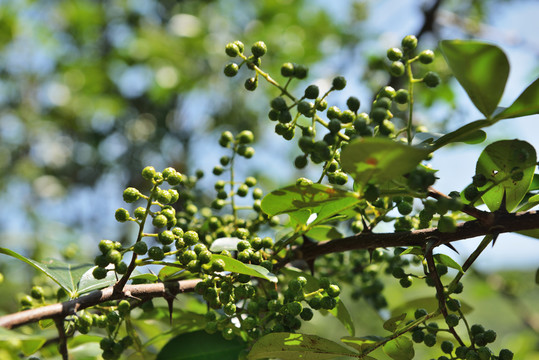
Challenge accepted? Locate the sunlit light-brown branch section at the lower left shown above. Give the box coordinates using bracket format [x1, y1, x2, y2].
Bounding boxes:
[0, 279, 201, 329]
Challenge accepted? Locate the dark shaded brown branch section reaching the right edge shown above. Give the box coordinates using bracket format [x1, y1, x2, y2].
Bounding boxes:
[300, 211, 539, 260]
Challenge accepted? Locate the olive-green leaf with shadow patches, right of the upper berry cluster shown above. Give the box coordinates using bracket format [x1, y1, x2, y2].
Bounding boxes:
[341, 138, 429, 186]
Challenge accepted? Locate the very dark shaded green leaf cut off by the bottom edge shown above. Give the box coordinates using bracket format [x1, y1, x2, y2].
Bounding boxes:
[156, 331, 247, 360]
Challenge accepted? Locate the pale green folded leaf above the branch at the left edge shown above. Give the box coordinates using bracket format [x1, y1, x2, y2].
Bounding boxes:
[0, 248, 94, 297]
